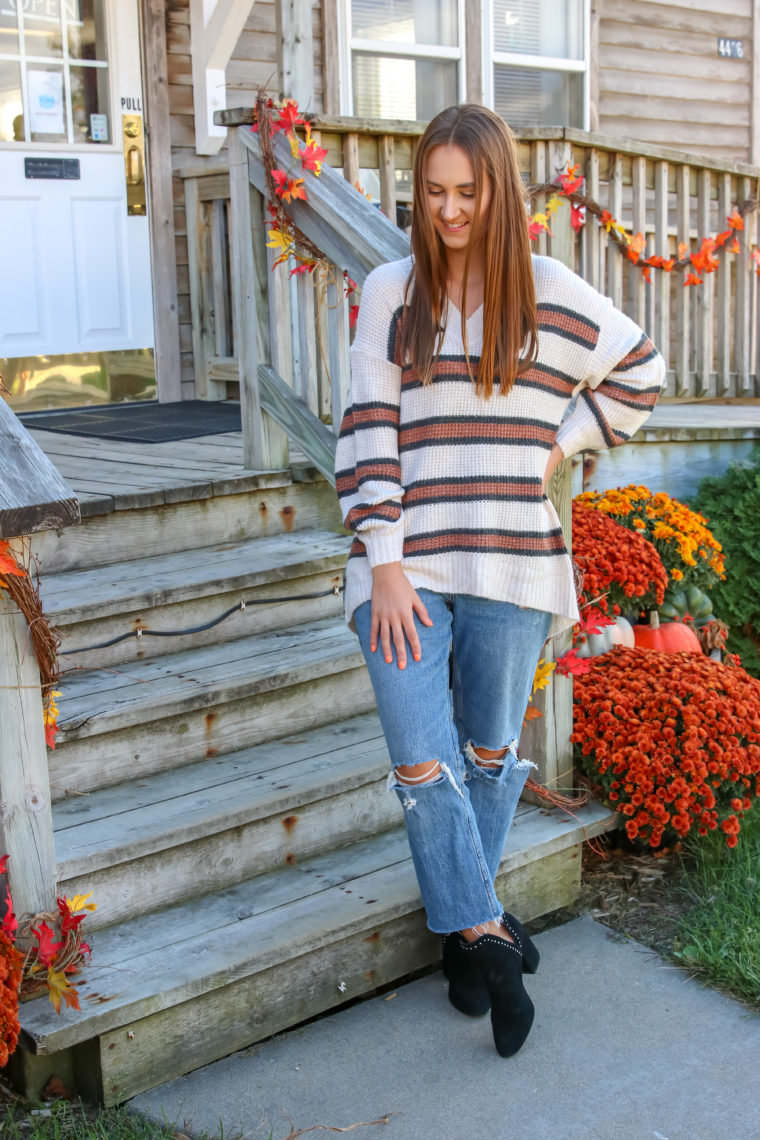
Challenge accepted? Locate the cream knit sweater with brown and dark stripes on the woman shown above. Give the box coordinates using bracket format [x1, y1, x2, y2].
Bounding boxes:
[335, 257, 665, 633]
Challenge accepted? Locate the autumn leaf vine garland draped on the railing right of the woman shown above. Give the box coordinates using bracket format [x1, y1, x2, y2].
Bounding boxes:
[525, 164, 760, 285]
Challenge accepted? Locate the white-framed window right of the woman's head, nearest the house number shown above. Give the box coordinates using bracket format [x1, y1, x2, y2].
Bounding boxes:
[485, 0, 589, 128]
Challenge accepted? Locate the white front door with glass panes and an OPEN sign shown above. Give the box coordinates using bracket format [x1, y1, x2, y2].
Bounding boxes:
[0, 0, 153, 410]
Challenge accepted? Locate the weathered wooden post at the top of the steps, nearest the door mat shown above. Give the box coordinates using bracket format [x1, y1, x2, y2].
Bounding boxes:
[228, 127, 271, 471]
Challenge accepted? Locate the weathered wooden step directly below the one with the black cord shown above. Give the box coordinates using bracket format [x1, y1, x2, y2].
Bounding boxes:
[49, 619, 374, 799]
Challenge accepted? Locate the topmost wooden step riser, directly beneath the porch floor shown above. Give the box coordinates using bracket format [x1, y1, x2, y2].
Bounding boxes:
[31, 472, 342, 576]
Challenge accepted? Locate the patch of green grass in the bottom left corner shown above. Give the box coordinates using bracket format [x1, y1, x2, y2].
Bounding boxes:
[0, 1100, 239, 1140]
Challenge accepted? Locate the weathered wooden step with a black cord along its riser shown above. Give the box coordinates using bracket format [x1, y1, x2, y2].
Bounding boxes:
[40, 530, 350, 670]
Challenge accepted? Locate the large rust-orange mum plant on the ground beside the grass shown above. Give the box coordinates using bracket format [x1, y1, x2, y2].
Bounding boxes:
[572, 648, 760, 847]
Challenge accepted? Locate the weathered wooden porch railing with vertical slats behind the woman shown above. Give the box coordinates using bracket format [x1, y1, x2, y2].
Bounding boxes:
[180, 108, 760, 420]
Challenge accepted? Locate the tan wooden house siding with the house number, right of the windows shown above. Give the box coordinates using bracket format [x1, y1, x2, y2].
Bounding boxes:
[591, 0, 753, 162]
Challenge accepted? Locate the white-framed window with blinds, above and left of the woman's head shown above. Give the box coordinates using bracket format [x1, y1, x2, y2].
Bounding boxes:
[343, 0, 464, 120]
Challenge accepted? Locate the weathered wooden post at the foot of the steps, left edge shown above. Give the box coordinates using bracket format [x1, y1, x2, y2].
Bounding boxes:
[0, 596, 56, 914]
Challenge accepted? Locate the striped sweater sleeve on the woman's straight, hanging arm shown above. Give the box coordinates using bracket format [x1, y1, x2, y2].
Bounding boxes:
[335, 266, 403, 567]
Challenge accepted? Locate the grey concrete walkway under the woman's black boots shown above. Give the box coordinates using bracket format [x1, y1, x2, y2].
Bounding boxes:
[132, 918, 760, 1140]
